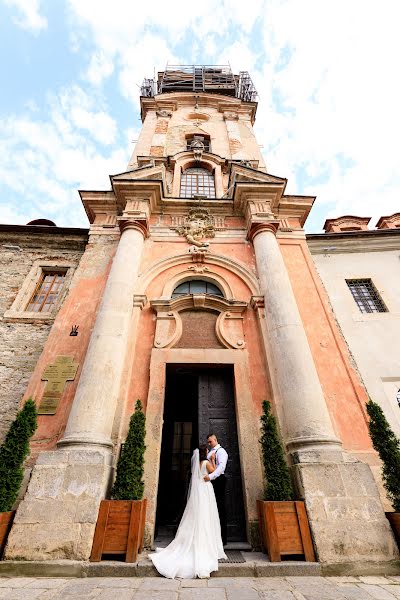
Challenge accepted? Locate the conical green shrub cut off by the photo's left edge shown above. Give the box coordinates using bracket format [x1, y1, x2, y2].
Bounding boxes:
[0, 399, 37, 512]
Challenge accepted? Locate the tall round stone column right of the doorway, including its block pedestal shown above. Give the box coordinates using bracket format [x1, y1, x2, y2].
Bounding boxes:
[249, 219, 398, 573]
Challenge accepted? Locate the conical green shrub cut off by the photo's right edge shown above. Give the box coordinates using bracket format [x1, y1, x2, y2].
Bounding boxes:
[367, 399, 400, 512]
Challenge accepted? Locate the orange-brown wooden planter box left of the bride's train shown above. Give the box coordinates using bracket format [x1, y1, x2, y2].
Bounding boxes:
[90, 500, 147, 562]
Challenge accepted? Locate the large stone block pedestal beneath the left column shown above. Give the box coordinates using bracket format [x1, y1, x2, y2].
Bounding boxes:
[5, 448, 112, 561]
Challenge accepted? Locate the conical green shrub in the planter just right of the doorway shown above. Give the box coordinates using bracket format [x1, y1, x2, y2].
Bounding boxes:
[260, 400, 294, 501]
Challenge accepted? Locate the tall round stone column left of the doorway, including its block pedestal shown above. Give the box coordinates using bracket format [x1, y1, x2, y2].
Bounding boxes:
[6, 218, 146, 560]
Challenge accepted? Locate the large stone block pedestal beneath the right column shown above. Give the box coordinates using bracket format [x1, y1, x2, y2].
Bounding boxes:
[292, 452, 399, 564]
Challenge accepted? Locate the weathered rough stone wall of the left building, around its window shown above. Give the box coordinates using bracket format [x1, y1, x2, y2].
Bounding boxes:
[0, 226, 87, 443]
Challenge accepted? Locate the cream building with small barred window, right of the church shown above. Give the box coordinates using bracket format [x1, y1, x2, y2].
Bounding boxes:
[307, 213, 400, 510]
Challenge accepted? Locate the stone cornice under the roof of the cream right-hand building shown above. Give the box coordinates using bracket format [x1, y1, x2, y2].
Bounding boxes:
[306, 229, 400, 254]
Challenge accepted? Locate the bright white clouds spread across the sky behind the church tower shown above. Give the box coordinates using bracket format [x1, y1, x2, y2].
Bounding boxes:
[0, 0, 400, 231]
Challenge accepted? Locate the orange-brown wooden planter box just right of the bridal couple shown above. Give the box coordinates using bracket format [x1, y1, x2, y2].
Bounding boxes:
[257, 500, 315, 562]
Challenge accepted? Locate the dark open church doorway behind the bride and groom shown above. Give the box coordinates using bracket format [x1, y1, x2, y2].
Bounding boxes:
[155, 364, 246, 542]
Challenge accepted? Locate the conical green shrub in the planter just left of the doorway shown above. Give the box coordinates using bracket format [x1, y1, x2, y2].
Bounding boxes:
[111, 400, 146, 500]
